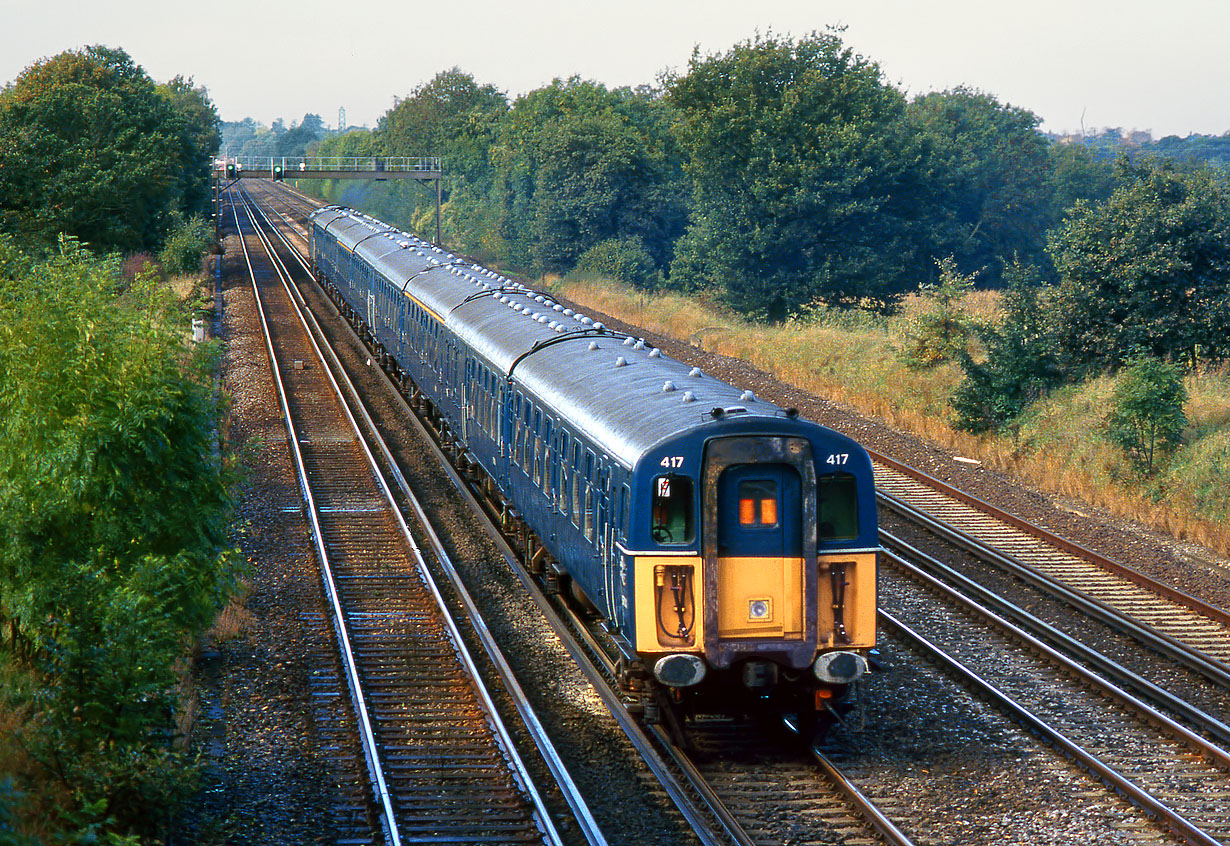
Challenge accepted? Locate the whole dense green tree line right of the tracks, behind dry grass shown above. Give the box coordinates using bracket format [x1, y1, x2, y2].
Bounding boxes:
[307, 32, 1230, 454]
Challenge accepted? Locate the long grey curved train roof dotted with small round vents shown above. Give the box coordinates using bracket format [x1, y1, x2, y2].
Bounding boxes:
[311, 207, 854, 467]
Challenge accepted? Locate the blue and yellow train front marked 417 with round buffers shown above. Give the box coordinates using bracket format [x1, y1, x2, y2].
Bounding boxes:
[635, 435, 876, 708]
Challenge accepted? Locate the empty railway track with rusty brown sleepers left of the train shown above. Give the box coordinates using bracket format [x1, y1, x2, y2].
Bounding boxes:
[231, 186, 568, 844]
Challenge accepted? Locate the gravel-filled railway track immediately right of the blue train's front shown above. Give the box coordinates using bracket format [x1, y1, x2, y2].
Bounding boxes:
[882, 560, 1230, 846]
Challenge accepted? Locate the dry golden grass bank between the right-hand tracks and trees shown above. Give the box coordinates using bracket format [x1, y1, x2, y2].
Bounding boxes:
[547, 279, 1230, 555]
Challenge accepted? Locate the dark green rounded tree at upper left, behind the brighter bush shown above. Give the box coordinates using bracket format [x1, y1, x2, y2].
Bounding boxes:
[0, 47, 186, 251]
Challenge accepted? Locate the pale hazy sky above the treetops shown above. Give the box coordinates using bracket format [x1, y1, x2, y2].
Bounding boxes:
[0, 0, 1230, 138]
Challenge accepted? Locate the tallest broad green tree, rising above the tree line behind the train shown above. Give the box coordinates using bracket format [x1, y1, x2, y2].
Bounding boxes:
[667, 33, 929, 317]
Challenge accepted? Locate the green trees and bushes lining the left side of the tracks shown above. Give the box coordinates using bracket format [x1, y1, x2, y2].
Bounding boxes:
[0, 47, 239, 844]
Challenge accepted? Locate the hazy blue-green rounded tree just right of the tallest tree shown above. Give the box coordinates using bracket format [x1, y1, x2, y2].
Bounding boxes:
[908, 87, 1054, 285]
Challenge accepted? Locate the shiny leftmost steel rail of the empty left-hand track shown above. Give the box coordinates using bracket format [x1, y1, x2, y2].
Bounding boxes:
[230, 196, 401, 846]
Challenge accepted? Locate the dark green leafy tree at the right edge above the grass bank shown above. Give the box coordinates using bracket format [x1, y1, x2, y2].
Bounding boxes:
[1050, 159, 1230, 370]
